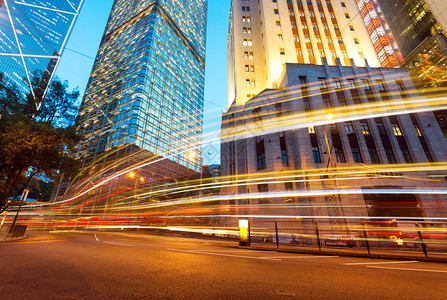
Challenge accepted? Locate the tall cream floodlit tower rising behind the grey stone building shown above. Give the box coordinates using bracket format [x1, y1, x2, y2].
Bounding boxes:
[228, 0, 381, 106]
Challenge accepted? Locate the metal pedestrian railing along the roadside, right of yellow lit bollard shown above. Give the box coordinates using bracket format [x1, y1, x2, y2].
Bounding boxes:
[242, 220, 447, 258]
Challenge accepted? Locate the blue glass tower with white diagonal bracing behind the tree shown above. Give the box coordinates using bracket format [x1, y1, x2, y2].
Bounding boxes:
[0, 0, 83, 100]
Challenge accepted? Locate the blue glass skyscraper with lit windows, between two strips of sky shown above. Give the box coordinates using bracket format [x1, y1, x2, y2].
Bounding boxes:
[77, 0, 207, 172]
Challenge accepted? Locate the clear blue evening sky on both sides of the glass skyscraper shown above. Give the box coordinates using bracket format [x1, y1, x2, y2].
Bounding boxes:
[56, 0, 231, 165]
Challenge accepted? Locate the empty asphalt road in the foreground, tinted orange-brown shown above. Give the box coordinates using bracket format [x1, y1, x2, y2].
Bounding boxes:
[0, 232, 447, 299]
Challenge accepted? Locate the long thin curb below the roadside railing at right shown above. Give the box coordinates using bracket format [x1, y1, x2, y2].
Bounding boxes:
[236, 246, 447, 263]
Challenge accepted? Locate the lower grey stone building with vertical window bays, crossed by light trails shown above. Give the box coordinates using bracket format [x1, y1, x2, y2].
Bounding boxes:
[221, 61, 447, 223]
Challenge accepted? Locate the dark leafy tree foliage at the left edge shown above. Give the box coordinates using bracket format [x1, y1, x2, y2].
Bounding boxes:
[0, 72, 80, 207]
